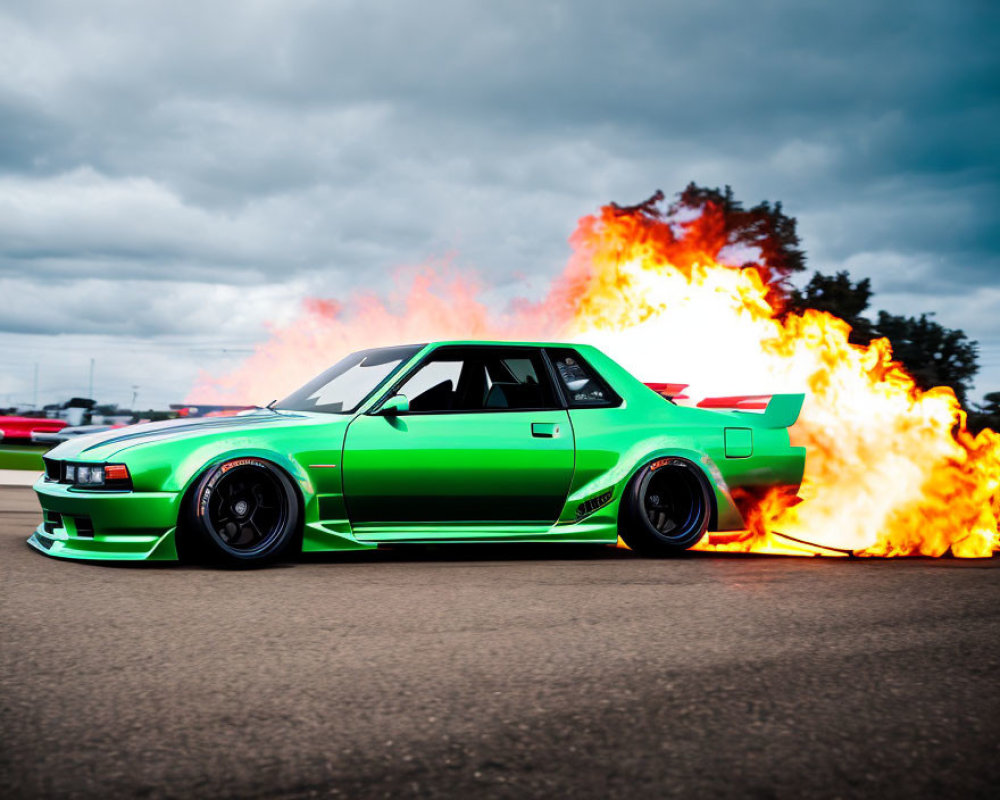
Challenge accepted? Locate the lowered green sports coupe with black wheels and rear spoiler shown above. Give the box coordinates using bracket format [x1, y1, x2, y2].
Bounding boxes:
[28, 342, 805, 564]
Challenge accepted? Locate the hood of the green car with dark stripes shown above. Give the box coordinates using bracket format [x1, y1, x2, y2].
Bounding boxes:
[46, 411, 332, 461]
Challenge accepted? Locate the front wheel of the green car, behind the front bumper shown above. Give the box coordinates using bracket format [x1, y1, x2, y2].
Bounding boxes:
[188, 458, 300, 567]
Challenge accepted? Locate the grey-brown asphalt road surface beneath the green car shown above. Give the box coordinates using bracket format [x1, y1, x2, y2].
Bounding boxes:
[0, 488, 1000, 798]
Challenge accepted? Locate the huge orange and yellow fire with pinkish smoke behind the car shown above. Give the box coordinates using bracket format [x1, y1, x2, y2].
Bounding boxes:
[192, 195, 1000, 557]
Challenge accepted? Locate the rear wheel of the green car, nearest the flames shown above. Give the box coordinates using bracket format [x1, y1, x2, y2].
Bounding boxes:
[618, 458, 712, 556]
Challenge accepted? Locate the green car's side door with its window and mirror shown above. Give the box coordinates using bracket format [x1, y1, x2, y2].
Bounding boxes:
[343, 346, 574, 541]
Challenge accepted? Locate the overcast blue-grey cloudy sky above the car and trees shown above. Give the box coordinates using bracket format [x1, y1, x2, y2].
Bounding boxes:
[0, 0, 1000, 405]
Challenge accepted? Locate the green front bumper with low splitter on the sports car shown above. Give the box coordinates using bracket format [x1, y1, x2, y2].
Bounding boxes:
[28, 478, 181, 561]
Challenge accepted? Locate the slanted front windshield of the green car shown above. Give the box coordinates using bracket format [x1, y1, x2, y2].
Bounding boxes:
[273, 344, 423, 414]
